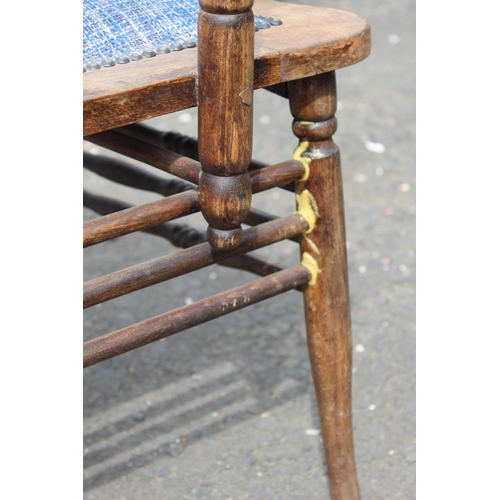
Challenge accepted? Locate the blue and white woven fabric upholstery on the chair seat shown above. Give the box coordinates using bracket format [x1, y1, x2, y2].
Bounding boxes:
[83, 0, 200, 65]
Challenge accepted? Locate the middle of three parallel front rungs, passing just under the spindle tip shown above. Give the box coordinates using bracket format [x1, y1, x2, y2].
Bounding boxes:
[83, 213, 309, 308]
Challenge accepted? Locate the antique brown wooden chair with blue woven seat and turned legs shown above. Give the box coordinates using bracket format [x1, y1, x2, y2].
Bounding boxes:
[83, 0, 370, 500]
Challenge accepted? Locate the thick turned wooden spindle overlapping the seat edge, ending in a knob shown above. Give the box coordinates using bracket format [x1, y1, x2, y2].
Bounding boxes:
[198, 0, 254, 249]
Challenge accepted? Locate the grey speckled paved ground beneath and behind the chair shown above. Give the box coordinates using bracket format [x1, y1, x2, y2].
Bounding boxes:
[84, 0, 416, 500]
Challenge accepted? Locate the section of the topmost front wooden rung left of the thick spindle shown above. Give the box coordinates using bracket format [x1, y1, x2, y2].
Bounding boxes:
[83, 191, 200, 248]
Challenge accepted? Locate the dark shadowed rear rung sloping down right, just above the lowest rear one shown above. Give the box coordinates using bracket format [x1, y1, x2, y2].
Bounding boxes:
[83, 152, 196, 196]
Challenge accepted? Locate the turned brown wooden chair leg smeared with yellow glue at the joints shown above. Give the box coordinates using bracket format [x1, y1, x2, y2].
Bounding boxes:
[288, 72, 359, 500]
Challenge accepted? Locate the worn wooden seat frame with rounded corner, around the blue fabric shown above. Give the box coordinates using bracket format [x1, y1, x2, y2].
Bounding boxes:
[83, 0, 370, 135]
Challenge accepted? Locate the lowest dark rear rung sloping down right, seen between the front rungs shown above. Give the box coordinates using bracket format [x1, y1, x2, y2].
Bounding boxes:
[83, 191, 283, 282]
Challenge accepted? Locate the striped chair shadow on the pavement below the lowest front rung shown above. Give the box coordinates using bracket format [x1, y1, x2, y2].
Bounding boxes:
[84, 292, 317, 492]
